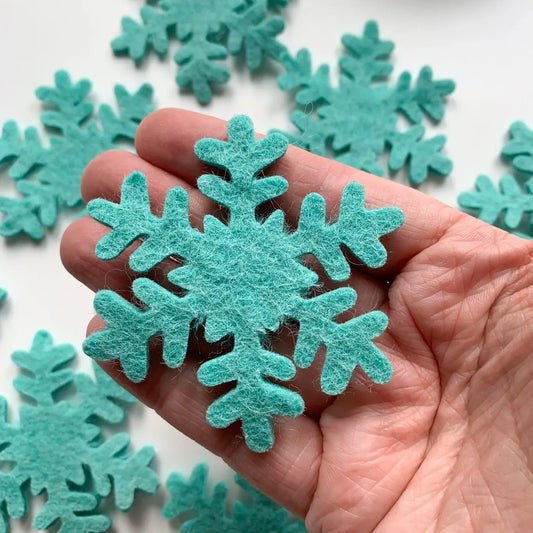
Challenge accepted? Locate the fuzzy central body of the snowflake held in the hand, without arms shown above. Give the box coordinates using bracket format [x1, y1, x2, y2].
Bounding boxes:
[179, 222, 316, 333]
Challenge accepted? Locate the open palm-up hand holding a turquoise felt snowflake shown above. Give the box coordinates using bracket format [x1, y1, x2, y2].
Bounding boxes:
[61, 109, 533, 533]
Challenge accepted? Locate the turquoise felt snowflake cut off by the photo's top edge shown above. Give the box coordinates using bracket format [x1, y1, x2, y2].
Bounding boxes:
[111, 0, 287, 104]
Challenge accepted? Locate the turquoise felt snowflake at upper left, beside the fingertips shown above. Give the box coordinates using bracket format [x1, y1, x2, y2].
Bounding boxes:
[0, 71, 153, 240]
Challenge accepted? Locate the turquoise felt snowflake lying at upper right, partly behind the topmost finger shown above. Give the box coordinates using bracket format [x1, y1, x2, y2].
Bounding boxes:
[278, 21, 455, 185]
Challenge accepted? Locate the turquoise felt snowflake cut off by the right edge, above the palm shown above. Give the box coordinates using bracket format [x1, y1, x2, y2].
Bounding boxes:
[458, 122, 533, 239]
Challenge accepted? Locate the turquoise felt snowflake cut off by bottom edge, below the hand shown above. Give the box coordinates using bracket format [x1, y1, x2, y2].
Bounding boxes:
[163, 463, 307, 533]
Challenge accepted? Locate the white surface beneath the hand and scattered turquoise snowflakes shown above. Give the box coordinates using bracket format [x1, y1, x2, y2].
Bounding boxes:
[0, 0, 533, 532]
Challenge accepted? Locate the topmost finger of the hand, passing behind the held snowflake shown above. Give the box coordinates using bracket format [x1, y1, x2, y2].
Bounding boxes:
[135, 109, 466, 276]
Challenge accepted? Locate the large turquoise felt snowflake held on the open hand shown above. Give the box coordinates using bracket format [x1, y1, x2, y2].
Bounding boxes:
[84, 116, 403, 451]
